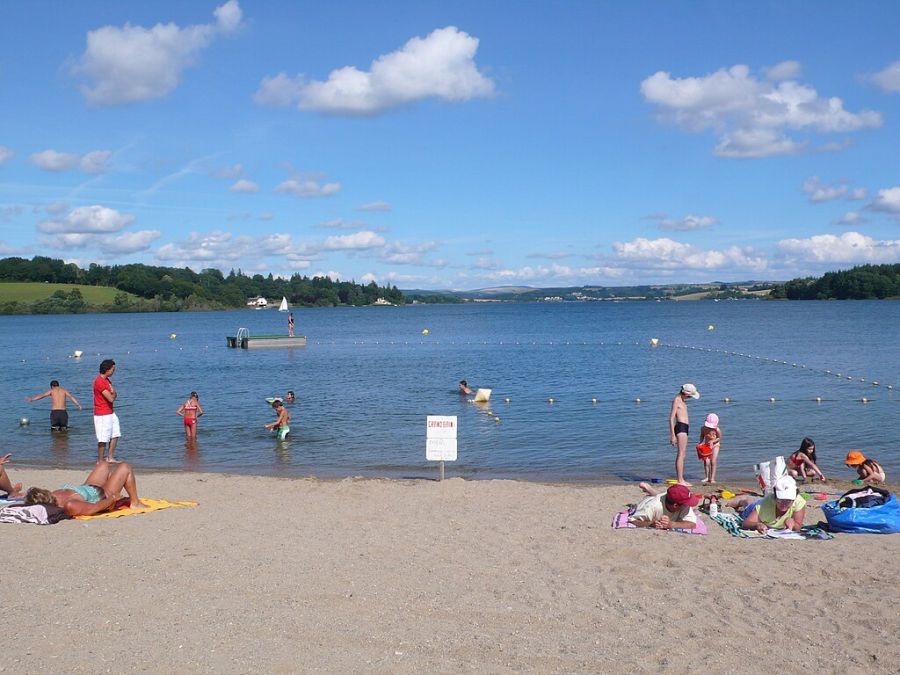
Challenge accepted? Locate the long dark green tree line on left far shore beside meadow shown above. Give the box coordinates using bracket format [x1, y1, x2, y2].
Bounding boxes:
[0, 256, 405, 312]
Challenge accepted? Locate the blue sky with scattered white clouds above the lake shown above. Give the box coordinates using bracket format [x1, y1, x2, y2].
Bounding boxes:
[0, 0, 900, 290]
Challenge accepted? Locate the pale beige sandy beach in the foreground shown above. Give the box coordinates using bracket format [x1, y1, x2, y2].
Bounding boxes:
[0, 464, 900, 673]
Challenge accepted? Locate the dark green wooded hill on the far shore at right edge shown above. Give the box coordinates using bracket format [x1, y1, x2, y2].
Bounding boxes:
[770, 264, 900, 300]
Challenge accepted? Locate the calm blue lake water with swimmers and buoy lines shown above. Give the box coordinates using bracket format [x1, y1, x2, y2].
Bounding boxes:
[0, 302, 900, 480]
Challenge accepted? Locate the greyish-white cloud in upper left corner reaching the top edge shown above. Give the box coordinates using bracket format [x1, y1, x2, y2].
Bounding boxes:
[73, 0, 242, 106]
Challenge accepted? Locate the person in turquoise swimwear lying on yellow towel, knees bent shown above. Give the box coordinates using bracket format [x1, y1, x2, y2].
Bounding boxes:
[25, 462, 146, 516]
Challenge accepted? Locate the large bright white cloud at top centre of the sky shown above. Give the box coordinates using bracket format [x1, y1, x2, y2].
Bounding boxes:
[255, 26, 494, 115]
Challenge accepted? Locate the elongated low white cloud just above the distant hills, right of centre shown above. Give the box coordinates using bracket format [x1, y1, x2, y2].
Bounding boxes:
[613, 237, 768, 272]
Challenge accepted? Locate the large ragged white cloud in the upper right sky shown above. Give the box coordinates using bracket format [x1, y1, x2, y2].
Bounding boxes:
[641, 62, 882, 157]
